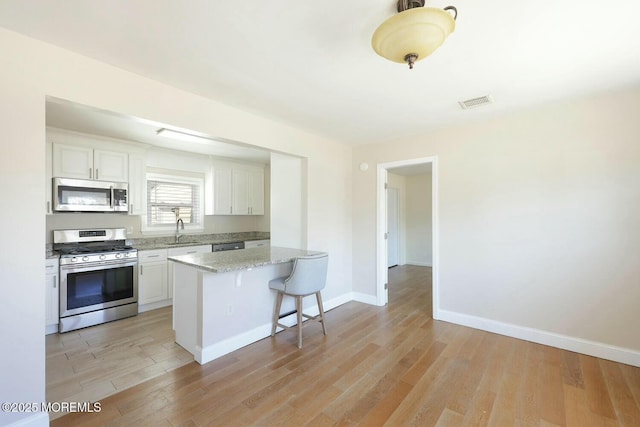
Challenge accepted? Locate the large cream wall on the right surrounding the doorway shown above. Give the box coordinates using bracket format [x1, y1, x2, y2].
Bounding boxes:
[352, 87, 640, 364]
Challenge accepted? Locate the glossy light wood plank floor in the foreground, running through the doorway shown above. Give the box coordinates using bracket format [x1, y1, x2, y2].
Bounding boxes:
[52, 266, 640, 427]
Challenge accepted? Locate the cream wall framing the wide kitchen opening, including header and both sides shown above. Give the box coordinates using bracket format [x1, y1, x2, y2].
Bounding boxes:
[0, 29, 352, 425]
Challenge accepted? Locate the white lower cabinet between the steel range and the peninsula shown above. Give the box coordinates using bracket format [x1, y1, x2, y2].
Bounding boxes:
[138, 249, 171, 312]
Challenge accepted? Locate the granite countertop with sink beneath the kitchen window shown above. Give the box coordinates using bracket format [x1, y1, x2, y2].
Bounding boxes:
[127, 231, 270, 251]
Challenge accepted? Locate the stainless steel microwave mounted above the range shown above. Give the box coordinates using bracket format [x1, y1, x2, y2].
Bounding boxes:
[53, 178, 129, 212]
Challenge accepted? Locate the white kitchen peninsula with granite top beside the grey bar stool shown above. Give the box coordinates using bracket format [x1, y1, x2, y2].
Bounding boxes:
[168, 246, 322, 364]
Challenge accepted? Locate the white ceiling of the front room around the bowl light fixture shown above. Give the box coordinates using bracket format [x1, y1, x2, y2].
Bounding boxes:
[0, 0, 640, 149]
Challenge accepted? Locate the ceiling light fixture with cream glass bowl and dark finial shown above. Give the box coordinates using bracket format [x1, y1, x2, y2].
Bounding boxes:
[371, 0, 458, 69]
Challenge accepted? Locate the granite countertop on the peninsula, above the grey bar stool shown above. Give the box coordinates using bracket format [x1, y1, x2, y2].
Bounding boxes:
[168, 246, 322, 273]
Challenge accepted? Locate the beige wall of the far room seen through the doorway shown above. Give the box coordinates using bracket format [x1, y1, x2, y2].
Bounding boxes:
[406, 173, 433, 267]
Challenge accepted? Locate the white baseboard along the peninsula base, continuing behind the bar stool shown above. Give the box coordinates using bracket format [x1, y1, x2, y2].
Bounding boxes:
[194, 293, 353, 365]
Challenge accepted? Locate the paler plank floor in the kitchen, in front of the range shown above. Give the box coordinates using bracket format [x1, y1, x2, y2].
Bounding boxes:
[46, 307, 193, 418]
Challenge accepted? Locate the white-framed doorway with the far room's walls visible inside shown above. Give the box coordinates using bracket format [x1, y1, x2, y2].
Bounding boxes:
[376, 157, 439, 319]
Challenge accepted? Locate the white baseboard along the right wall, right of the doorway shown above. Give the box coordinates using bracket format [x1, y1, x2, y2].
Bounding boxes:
[434, 310, 640, 367]
